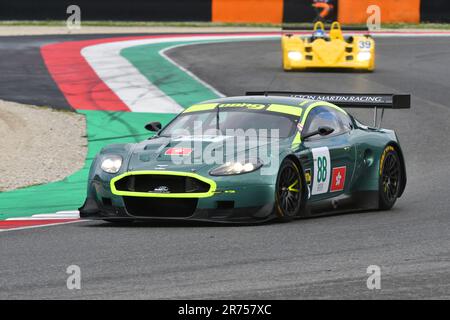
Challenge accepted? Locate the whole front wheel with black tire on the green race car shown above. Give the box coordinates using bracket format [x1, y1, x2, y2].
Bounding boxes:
[274, 159, 303, 222]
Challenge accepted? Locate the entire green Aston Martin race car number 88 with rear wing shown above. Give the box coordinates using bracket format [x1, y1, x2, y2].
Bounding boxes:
[80, 92, 410, 223]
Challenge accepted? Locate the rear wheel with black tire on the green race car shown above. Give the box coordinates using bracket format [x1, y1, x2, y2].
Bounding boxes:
[378, 146, 403, 210]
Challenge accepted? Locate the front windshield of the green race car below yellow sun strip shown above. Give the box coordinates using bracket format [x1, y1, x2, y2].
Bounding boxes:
[160, 109, 297, 138]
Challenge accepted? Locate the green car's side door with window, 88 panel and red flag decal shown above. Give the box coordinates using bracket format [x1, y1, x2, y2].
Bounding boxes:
[302, 105, 356, 201]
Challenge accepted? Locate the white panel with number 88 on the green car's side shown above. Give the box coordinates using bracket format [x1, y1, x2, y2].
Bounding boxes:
[311, 147, 331, 195]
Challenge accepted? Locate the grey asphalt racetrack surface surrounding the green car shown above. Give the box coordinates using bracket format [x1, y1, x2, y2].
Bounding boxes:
[0, 38, 450, 299]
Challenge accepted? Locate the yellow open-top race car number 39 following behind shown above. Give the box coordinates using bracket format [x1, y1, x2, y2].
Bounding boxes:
[281, 21, 375, 71]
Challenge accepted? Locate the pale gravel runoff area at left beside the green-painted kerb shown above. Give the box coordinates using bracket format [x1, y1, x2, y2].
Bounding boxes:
[0, 100, 87, 192]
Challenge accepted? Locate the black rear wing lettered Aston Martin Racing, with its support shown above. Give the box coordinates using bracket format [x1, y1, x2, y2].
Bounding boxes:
[246, 91, 411, 128]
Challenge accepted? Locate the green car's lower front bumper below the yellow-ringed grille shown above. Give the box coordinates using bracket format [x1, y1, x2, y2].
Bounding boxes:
[79, 172, 275, 223]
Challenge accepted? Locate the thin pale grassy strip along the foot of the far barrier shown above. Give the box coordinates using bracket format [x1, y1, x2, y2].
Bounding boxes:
[0, 20, 450, 30]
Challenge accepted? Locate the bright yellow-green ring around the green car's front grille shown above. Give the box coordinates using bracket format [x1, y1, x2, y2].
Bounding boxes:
[110, 170, 217, 198]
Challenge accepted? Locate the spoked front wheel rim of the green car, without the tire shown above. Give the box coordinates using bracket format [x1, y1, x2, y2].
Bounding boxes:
[277, 166, 301, 216]
